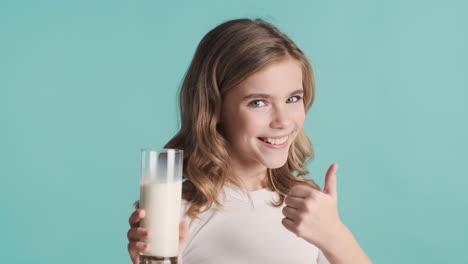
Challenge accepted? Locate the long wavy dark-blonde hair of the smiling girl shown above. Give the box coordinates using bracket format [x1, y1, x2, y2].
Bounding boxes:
[165, 19, 320, 218]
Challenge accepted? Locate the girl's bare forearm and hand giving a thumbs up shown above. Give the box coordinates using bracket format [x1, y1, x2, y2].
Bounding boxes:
[281, 163, 372, 264]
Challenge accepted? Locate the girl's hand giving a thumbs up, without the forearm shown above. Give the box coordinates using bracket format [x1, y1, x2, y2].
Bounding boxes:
[281, 163, 346, 248]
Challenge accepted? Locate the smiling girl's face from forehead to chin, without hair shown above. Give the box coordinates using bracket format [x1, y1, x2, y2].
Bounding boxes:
[221, 58, 305, 168]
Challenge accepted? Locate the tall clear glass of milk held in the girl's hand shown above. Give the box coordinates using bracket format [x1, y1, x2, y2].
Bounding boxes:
[140, 149, 183, 264]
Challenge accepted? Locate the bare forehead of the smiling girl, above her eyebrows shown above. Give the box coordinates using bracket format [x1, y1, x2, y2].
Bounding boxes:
[233, 58, 302, 95]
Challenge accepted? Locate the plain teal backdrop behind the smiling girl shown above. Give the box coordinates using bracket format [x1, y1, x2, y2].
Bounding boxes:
[0, 0, 468, 264]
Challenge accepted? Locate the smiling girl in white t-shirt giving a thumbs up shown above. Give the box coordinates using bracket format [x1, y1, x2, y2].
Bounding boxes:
[128, 19, 371, 264]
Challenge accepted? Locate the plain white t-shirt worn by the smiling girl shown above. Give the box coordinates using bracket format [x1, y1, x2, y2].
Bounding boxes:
[182, 183, 329, 264]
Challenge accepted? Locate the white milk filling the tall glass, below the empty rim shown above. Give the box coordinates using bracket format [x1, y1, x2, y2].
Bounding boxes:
[140, 182, 182, 257]
